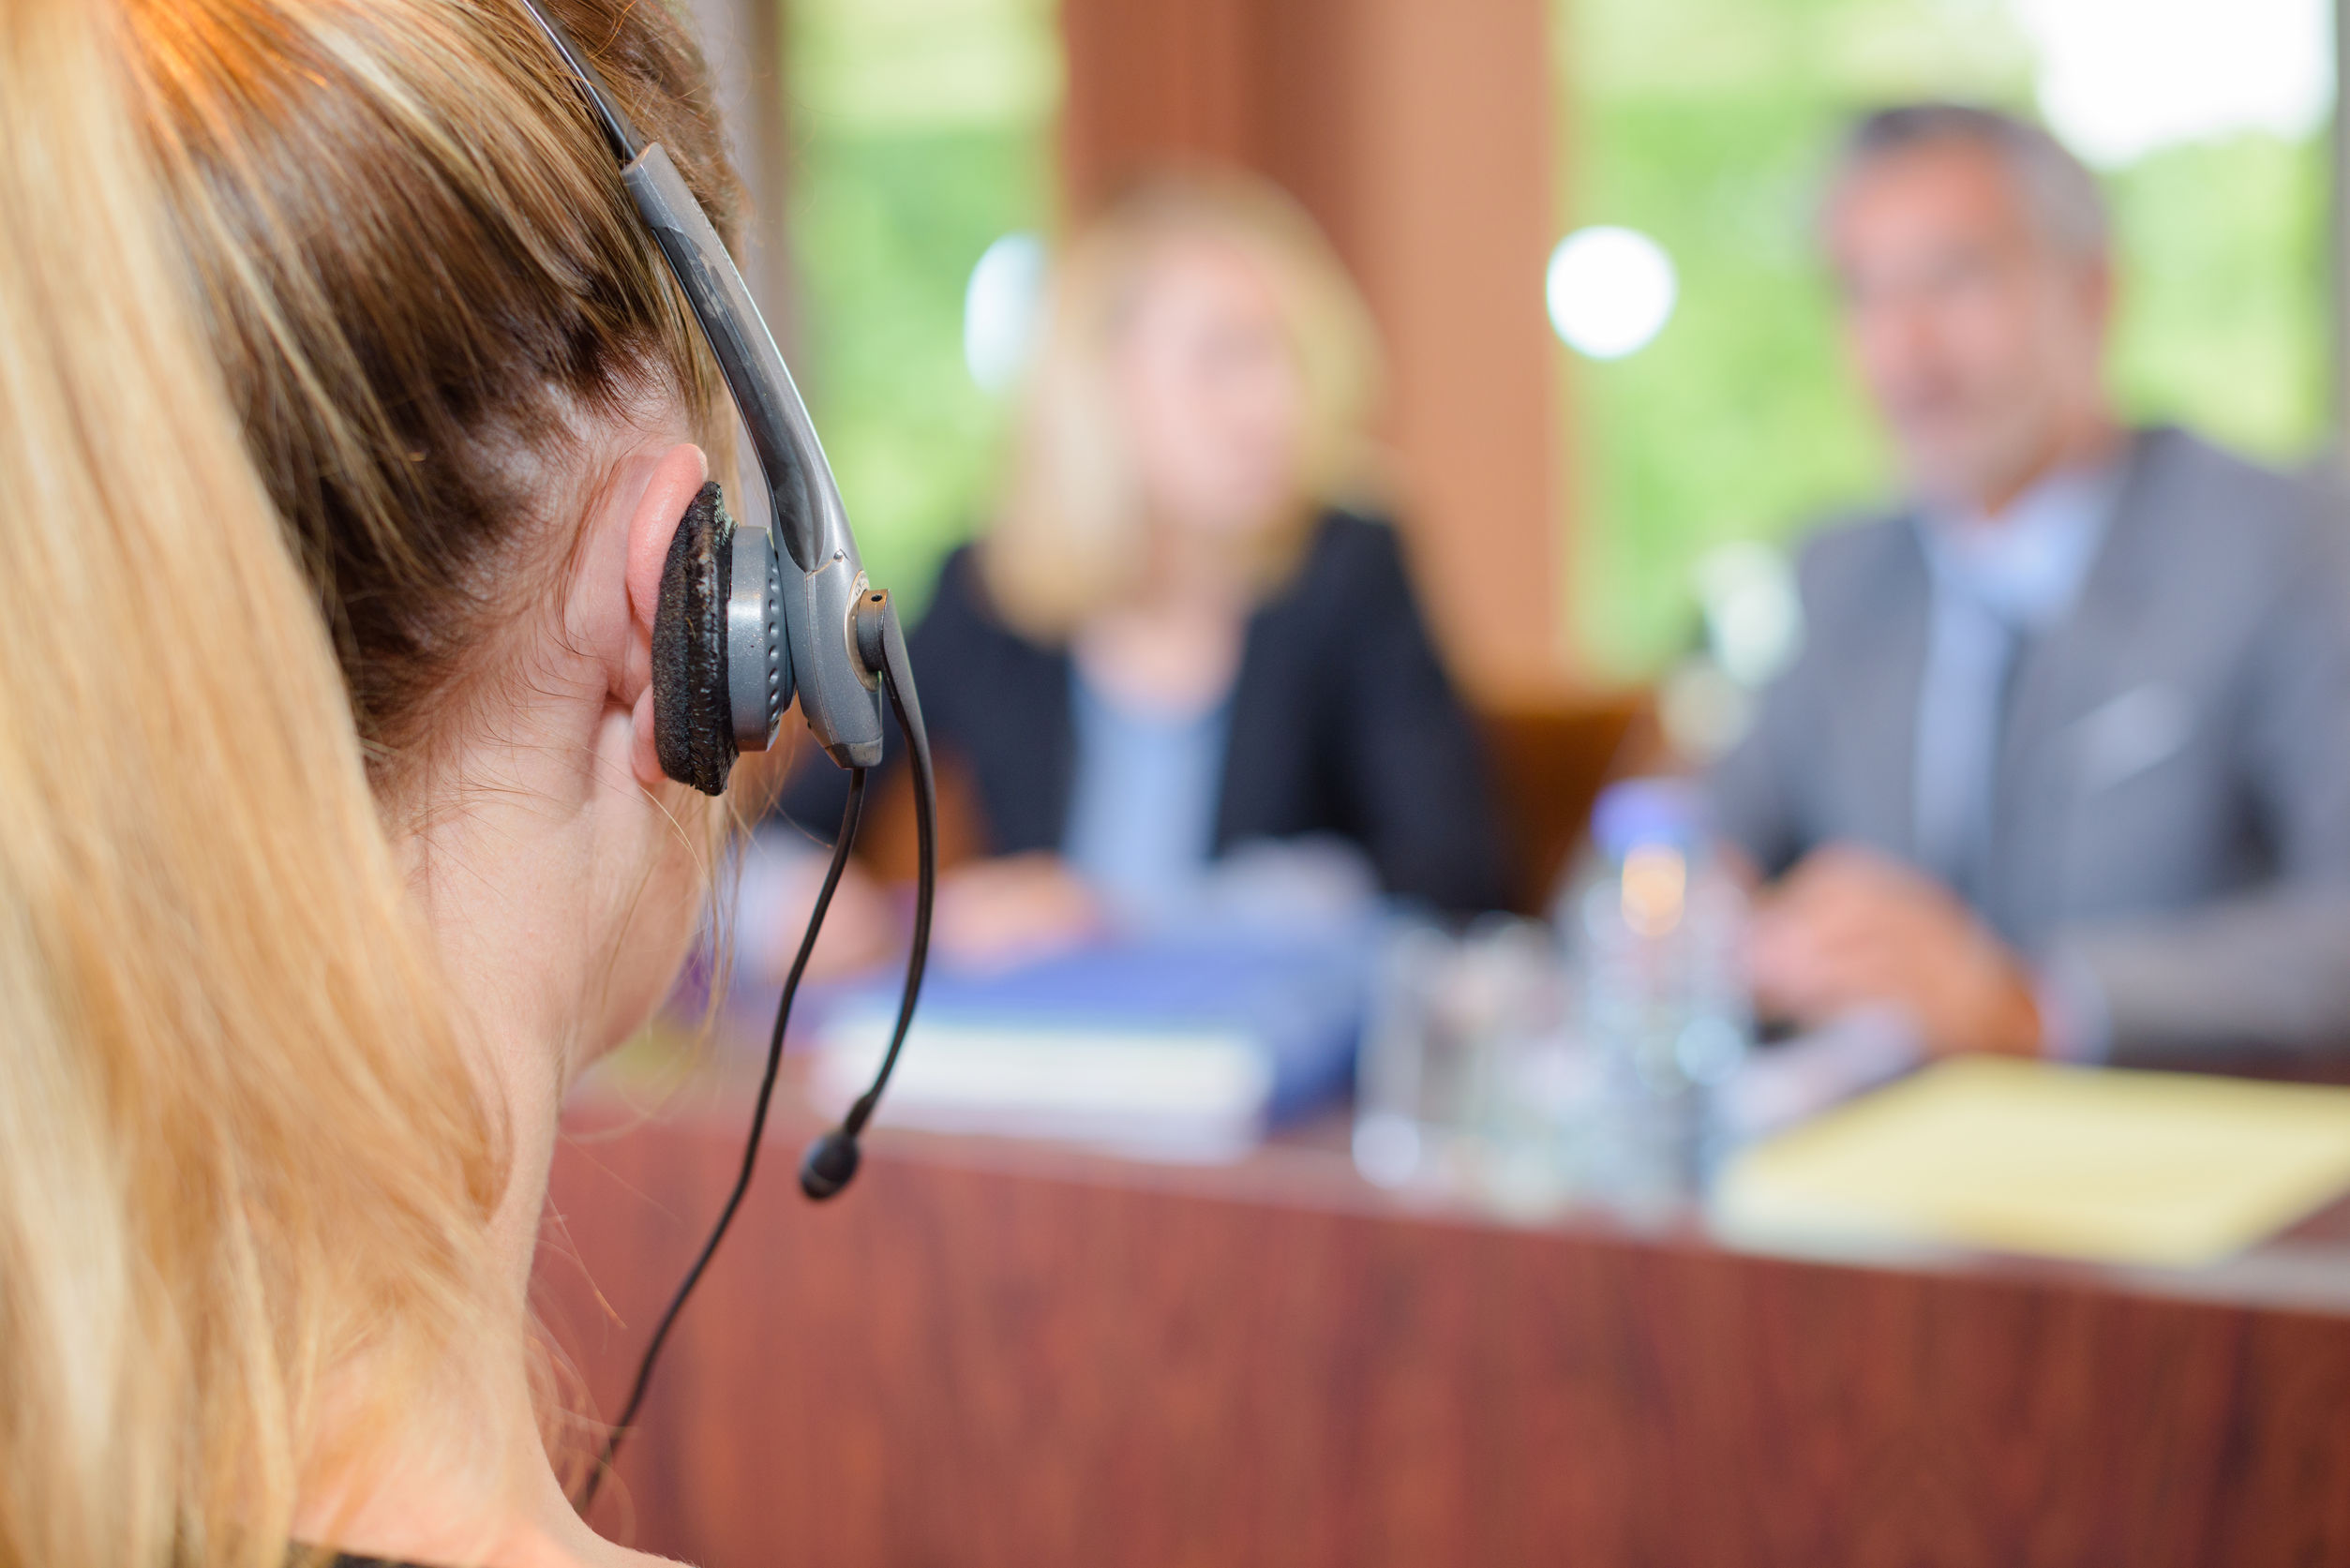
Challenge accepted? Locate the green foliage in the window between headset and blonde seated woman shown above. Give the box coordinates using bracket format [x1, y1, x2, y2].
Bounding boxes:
[785, 0, 1060, 609]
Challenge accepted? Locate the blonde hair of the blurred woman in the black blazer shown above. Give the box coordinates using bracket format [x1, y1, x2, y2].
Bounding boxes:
[980, 170, 1380, 642]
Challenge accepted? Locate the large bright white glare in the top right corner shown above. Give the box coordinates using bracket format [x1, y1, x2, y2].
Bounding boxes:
[2016, 0, 2333, 170]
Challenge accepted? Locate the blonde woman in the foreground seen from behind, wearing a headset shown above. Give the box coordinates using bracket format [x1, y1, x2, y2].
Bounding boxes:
[0, 0, 752, 1568]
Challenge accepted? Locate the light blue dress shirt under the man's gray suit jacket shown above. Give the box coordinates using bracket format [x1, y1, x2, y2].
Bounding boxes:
[1913, 466, 2119, 1058]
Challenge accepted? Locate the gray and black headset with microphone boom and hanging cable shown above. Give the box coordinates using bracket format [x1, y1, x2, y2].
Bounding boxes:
[522, 0, 937, 1512]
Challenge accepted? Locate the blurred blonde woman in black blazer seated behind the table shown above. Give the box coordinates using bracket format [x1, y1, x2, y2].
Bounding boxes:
[780, 174, 1502, 957]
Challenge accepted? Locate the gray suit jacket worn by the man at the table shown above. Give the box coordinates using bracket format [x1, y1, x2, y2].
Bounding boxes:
[1714, 430, 2350, 1060]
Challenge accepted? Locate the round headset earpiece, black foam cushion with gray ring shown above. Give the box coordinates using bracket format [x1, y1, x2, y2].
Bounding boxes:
[653, 482, 792, 795]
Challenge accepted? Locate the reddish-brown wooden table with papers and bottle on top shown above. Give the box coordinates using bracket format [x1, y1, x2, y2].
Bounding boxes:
[541, 1081, 2350, 1568]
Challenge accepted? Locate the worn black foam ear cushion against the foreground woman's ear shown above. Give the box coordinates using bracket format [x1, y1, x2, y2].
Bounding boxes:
[653, 485, 736, 795]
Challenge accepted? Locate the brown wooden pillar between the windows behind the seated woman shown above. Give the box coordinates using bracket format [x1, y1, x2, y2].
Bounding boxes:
[1062, 0, 1567, 698]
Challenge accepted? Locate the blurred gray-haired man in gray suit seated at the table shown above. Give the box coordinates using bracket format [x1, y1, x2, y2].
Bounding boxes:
[1714, 106, 2350, 1060]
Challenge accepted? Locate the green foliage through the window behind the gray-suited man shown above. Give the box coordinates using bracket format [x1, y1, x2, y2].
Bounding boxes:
[1556, 0, 2328, 677]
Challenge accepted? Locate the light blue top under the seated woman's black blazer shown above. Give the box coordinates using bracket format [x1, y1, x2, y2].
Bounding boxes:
[1062, 661, 1232, 926]
